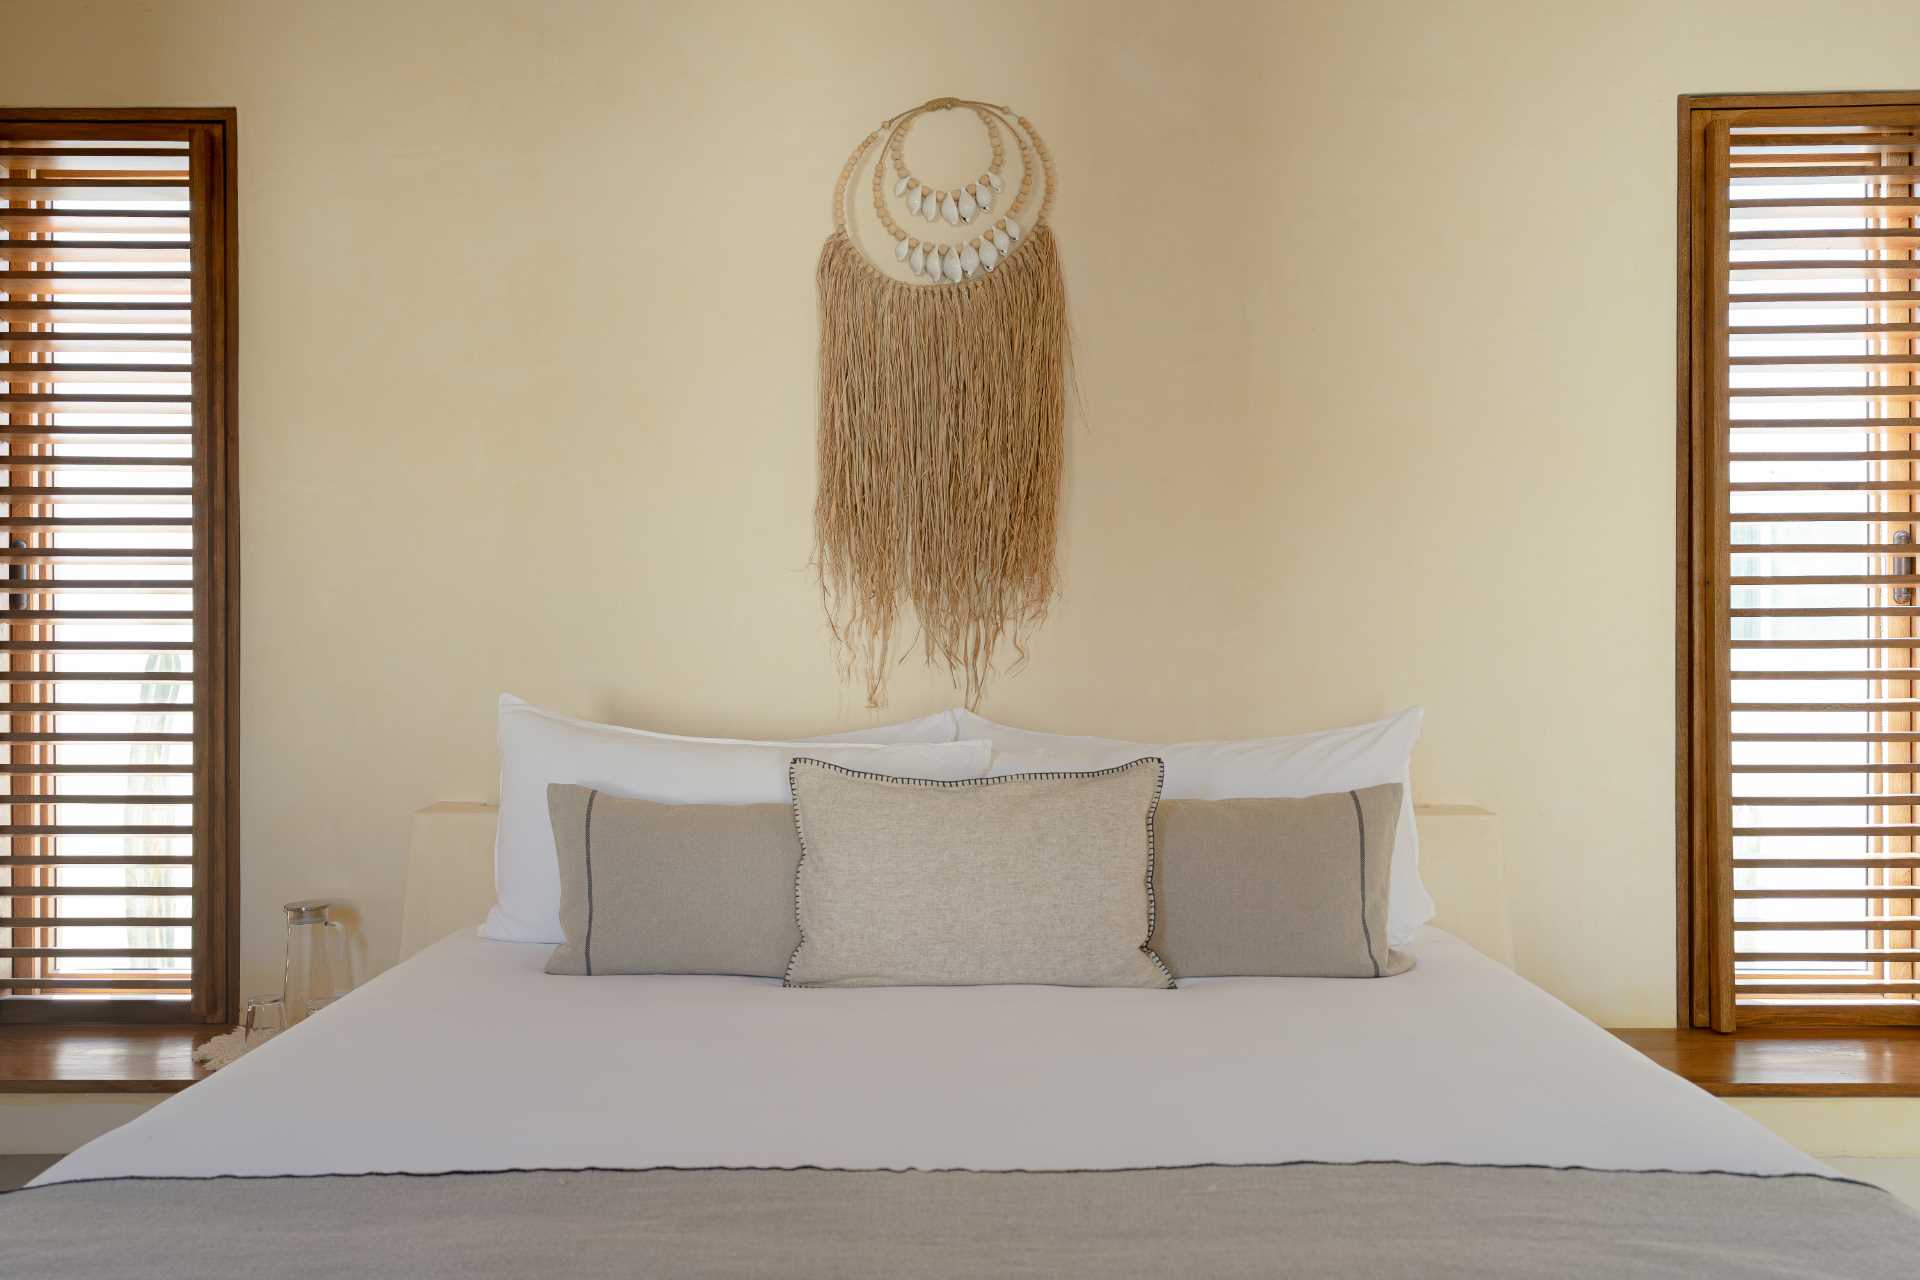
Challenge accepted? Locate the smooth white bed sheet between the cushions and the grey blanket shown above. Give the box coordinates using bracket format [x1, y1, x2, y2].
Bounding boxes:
[38, 929, 1830, 1184]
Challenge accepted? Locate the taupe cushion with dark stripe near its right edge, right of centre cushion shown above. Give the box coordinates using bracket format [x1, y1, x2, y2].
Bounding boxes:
[1152, 783, 1413, 979]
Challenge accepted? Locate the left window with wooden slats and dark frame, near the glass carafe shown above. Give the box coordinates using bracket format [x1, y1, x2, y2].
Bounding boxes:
[0, 111, 238, 1023]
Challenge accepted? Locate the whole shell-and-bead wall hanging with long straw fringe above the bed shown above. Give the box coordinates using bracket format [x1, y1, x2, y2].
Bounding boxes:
[814, 98, 1068, 706]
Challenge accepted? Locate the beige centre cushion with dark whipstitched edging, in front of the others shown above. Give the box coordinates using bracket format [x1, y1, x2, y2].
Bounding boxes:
[787, 758, 1173, 986]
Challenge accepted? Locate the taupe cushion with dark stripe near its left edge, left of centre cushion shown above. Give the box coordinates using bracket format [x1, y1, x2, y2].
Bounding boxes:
[547, 783, 801, 977]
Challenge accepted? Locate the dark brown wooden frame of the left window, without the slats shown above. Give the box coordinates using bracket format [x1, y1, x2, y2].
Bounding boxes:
[0, 107, 240, 1025]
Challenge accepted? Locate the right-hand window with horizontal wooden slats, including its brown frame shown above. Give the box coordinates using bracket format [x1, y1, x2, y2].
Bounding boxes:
[1680, 94, 1920, 1031]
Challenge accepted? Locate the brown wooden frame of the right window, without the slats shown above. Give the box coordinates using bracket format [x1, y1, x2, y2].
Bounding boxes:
[1674, 90, 1920, 1032]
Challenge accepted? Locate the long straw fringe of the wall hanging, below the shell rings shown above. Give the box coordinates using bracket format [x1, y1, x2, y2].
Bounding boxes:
[814, 223, 1068, 706]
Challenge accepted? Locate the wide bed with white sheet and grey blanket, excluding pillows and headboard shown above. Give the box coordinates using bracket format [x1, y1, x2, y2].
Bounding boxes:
[0, 805, 1920, 1280]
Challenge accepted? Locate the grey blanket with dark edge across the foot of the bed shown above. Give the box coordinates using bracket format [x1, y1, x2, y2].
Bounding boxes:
[0, 1165, 1920, 1280]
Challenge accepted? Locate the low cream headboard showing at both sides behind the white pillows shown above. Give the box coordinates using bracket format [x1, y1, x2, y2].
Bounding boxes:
[399, 800, 1513, 967]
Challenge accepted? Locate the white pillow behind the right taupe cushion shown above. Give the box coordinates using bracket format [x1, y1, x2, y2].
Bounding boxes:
[954, 706, 1434, 946]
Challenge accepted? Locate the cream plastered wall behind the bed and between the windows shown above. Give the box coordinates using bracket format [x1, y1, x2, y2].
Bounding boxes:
[11, 0, 1920, 1023]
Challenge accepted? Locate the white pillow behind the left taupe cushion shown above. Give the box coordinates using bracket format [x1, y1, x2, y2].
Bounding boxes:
[480, 693, 993, 942]
